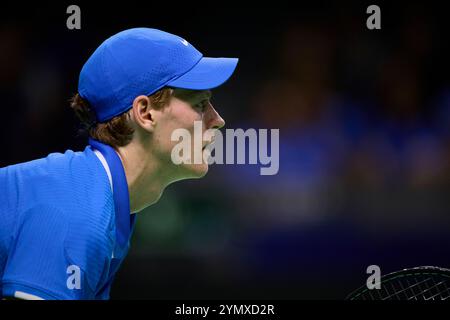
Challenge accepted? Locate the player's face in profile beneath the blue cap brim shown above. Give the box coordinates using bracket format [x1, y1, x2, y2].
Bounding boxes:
[149, 89, 225, 179]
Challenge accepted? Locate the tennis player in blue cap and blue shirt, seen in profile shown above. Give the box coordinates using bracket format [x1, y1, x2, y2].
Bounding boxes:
[0, 28, 238, 299]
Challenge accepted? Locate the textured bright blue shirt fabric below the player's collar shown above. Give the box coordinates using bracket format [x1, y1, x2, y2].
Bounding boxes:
[0, 146, 134, 299]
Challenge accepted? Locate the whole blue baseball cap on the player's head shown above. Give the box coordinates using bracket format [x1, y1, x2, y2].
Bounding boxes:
[78, 28, 238, 122]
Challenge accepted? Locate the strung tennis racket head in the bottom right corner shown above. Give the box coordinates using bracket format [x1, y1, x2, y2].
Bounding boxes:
[346, 266, 450, 301]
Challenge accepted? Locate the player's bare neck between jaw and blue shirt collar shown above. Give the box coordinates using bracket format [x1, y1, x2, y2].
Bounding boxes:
[115, 142, 170, 213]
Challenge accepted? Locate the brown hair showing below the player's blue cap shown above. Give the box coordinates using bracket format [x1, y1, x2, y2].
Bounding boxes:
[70, 88, 172, 147]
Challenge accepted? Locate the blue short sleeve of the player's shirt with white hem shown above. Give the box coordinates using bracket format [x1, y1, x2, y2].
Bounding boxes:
[2, 205, 104, 300]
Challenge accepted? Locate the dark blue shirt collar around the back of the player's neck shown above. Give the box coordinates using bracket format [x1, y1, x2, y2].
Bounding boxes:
[89, 138, 136, 249]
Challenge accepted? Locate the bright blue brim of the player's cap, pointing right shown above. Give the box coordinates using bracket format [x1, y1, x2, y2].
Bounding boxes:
[167, 57, 239, 90]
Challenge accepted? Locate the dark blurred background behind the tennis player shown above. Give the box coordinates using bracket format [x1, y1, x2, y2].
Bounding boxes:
[0, 1, 450, 299]
